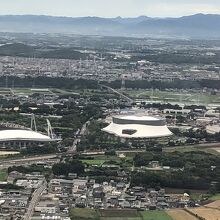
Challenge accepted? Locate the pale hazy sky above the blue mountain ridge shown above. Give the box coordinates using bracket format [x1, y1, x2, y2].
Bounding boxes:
[0, 0, 220, 17]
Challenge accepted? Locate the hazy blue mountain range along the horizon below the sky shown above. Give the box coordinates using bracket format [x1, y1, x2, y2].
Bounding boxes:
[0, 14, 220, 39]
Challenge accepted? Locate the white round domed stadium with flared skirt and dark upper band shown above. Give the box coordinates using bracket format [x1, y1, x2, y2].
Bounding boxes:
[102, 115, 172, 138]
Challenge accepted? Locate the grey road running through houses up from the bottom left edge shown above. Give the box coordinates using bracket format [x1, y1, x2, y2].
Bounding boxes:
[24, 182, 47, 220]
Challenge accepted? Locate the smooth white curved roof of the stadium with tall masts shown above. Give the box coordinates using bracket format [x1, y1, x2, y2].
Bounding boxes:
[0, 129, 52, 142]
